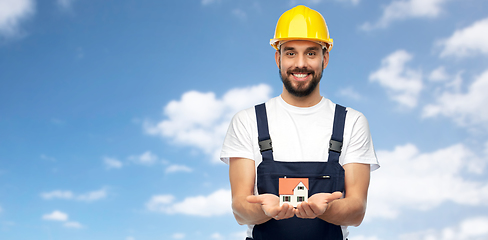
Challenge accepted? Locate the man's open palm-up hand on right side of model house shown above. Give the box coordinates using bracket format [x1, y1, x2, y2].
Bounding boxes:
[294, 192, 342, 218]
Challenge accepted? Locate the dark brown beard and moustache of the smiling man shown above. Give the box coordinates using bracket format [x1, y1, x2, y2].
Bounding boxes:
[279, 66, 322, 97]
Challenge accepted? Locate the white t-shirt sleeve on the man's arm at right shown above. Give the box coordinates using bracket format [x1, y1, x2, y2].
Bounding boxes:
[343, 113, 380, 171]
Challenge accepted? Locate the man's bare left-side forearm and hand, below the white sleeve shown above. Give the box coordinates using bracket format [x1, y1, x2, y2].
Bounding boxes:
[229, 158, 293, 225]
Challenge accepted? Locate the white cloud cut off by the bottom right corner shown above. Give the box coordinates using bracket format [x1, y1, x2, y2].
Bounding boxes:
[400, 216, 488, 240]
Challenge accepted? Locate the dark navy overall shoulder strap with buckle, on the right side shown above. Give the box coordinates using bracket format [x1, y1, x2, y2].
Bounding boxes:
[327, 104, 346, 162]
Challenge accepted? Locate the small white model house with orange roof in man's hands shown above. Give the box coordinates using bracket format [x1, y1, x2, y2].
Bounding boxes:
[279, 178, 308, 207]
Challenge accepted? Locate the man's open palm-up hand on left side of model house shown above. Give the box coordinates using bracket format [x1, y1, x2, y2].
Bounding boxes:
[246, 194, 294, 220]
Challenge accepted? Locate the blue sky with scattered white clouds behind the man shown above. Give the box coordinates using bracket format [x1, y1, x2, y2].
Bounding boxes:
[0, 0, 488, 240]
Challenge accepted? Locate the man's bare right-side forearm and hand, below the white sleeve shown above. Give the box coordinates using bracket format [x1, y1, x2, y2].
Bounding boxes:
[295, 163, 370, 226]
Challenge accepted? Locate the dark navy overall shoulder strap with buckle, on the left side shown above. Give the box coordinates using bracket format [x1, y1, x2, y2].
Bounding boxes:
[254, 103, 273, 161]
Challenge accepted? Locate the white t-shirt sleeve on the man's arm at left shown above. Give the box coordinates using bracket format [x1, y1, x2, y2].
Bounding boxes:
[220, 110, 254, 164]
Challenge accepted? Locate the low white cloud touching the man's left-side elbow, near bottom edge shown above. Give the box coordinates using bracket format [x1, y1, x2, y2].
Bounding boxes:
[146, 189, 232, 217]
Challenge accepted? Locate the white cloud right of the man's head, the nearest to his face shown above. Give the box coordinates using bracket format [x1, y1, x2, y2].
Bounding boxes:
[369, 50, 423, 108]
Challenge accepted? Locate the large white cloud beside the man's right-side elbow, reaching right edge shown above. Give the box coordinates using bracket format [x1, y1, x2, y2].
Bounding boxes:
[366, 144, 488, 220]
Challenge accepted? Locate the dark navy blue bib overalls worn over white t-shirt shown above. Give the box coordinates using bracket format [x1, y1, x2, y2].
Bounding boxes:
[248, 103, 346, 240]
